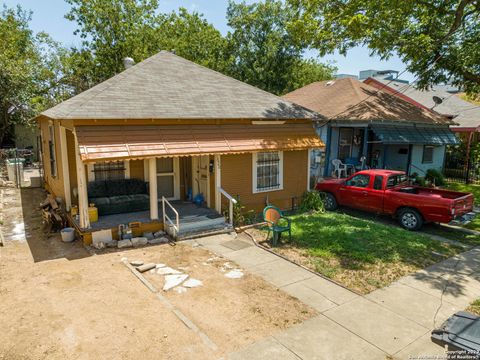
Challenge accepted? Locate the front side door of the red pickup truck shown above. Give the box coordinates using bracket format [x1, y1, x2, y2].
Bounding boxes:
[338, 174, 371, 210]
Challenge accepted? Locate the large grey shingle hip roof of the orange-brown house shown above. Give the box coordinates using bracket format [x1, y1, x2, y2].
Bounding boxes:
[42, 51, 318, 119]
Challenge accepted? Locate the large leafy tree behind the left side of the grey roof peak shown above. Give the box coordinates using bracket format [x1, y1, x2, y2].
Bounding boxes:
[64, 0, 229, 87]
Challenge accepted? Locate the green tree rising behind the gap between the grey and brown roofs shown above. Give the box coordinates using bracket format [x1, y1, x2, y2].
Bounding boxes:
[227, 0, 334, 95]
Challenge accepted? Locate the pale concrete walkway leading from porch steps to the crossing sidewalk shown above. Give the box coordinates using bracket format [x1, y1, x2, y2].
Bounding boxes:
[187, 234, 480, 360]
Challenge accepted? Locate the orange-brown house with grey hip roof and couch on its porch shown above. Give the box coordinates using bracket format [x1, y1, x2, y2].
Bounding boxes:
[37, 51, 324, 243]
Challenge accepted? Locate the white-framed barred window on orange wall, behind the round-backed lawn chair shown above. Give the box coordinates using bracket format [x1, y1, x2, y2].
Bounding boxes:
[253, 151, 283, 193]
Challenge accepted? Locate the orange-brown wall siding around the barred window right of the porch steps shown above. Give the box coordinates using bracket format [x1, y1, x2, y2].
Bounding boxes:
[221, 150, 308, 211]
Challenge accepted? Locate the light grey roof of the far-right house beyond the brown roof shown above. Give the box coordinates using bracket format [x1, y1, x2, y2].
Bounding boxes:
[375, 79, 480, 127]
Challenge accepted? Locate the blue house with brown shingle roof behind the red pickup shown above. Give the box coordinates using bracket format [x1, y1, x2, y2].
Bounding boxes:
[283, 78, 457, 178]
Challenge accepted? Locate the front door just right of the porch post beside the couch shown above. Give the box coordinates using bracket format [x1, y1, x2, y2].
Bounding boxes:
[157, 158, 180, 200]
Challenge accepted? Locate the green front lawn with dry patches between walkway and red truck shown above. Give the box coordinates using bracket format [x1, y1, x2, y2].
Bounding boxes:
[266, 212, 462, 294]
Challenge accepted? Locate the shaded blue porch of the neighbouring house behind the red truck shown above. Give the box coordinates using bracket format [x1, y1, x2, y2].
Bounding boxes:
[322, 124, 457, 177]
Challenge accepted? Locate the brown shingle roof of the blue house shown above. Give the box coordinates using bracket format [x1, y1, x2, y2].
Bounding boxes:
[283, 78, 451, 124]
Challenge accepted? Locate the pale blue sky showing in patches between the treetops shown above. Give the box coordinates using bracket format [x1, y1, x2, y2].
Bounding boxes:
[0, 0, 414, 81]
